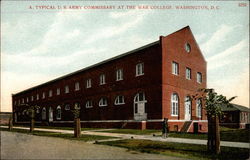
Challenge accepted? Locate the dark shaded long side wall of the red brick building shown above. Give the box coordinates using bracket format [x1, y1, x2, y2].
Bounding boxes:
[13, 44, 162, 120]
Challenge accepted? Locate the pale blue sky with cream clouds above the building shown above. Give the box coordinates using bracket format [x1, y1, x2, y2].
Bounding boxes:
[0, 1, 249, 112]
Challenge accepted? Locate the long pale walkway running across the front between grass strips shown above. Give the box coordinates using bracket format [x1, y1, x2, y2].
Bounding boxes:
[1, 127, 250, 148]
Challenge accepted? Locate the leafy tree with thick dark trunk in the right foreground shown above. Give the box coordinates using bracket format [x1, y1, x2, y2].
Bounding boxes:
[192, 89, 236, 154]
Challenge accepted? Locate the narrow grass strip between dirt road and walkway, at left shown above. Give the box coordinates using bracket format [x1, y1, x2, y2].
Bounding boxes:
[0, 128, 115, 141]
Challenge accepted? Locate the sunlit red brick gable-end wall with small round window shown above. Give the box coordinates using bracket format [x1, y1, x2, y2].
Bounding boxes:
[161, 27, 207, 119]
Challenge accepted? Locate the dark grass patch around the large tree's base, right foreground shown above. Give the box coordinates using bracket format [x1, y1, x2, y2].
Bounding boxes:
[97, 140, 249, 160]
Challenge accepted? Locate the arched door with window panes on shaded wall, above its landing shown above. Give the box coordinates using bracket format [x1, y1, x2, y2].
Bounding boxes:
[134, 92, 147, 114]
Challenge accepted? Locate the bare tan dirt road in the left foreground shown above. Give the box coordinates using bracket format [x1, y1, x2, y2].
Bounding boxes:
[0, 131, 184, 160]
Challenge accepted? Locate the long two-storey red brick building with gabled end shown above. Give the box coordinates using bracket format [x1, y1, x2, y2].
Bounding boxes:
[12, 26, 207, 132]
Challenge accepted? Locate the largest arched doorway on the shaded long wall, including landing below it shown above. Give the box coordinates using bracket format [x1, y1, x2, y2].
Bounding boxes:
[134, 92, 147, 120]
